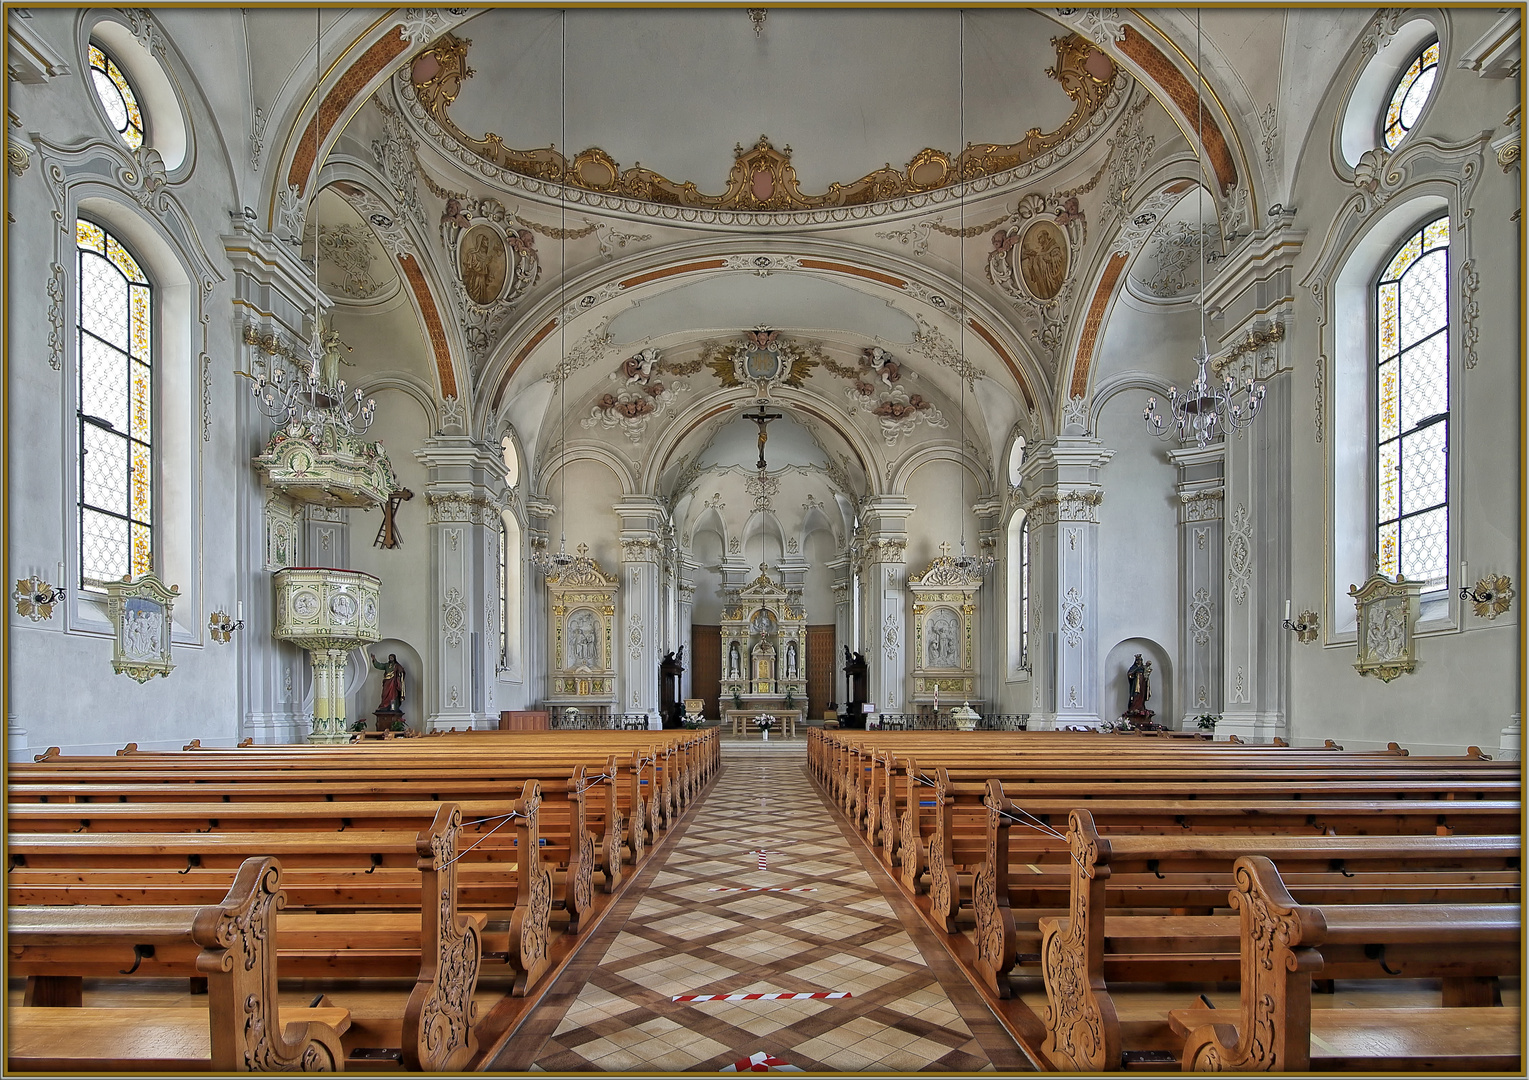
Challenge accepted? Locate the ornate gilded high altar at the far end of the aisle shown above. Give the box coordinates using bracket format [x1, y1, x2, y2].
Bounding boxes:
[722, 566, 807, 716]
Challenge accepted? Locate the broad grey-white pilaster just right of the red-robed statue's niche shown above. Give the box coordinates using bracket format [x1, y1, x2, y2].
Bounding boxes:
[414, 436, 505, 730]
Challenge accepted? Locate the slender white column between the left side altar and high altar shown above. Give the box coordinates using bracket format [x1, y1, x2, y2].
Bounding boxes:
[612, 496, 664, 719]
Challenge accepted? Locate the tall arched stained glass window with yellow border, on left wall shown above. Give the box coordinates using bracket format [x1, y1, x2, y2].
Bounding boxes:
[75, 219, 154, 584]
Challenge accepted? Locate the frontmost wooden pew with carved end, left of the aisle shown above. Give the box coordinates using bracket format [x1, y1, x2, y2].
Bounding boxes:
[6, 858, 350, 1072]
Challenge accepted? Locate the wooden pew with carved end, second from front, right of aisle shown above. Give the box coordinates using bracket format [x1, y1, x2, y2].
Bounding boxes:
[1041, 809, 1521, 1072]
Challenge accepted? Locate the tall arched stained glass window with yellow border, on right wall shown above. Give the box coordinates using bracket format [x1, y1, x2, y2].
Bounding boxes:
[1375, 217, 1449, 592]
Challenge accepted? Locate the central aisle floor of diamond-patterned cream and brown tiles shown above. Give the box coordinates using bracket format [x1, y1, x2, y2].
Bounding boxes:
[494, 743, 1031, 1072]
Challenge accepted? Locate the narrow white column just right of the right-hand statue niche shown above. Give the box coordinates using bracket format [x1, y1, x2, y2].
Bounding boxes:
[1162, 444, 1226, 731]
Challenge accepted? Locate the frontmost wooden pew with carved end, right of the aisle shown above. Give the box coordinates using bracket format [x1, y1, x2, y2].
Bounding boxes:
[1168, 855, 1523, 1072]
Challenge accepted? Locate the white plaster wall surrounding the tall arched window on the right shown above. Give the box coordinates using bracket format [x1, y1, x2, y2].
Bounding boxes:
[1289, 8, 1523, 754]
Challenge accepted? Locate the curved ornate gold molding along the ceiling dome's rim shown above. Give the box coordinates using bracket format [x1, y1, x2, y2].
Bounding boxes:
[410, 34, 1119, 211]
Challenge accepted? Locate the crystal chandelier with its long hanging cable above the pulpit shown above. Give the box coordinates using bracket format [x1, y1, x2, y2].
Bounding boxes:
[240, 10, 378, 445]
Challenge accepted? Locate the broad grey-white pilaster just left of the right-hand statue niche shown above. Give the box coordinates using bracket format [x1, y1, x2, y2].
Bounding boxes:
[1024, 436, 1115, 730]
